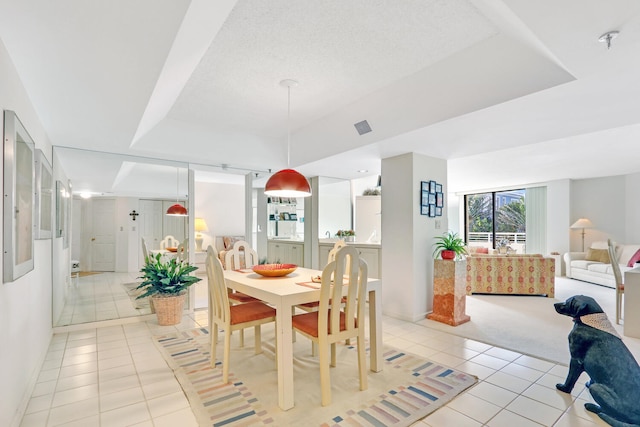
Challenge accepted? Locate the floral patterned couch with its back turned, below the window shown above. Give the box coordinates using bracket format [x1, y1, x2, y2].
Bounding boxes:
[467, 254, 556, 298]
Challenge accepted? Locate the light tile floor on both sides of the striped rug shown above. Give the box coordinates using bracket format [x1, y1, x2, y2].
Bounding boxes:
[21, 276, 606, 427]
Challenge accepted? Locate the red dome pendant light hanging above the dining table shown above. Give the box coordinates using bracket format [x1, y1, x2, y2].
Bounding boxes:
[264, 79, 311, 197]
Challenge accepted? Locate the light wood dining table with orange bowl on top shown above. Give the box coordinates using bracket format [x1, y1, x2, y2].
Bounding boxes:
[224, 268, 383, 410]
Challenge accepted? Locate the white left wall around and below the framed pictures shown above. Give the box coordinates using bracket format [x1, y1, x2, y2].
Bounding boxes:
[0, 40, 52, 426]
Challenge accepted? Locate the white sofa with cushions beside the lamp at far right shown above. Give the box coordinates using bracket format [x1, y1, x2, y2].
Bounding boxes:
[564, 242, 640, 288]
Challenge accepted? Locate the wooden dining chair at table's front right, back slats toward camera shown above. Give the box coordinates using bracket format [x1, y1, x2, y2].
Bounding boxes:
[291, 246, 367, 406]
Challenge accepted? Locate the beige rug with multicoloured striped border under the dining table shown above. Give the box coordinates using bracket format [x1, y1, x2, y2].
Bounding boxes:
[154, 325, 477, 427]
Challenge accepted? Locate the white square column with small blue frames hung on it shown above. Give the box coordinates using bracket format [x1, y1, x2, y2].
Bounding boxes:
[382, 153, 448, 321]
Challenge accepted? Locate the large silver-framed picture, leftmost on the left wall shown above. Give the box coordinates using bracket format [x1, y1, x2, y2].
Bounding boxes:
[3, 110, 36, 283]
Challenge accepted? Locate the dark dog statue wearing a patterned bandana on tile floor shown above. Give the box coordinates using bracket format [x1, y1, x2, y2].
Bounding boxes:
[554, 295, 640, 427]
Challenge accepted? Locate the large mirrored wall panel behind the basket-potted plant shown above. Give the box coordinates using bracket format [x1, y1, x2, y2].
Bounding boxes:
[52, 147, 190, 326]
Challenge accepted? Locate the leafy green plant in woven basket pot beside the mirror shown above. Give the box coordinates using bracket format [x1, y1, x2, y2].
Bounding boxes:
[136, 254, 201, 326]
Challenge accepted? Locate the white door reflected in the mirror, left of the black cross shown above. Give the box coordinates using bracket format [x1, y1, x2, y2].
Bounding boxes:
[91, 199, 116, 271]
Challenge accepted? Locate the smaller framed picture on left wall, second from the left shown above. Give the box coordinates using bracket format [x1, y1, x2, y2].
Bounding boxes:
[35, 150, 53, 239]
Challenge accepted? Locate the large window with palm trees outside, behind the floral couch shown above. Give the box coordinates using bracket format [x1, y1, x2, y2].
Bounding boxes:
[465, 190, 527, 253]
